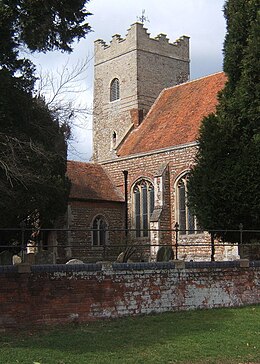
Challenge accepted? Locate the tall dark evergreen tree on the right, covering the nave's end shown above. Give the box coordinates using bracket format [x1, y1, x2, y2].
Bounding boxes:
[189, 0, 260, 242]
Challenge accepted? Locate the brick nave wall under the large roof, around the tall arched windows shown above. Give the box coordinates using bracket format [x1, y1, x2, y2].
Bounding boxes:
[102, 145, 197, 253]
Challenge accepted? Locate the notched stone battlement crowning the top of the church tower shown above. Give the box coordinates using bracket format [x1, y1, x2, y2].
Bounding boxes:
[95, 23, 189, 64]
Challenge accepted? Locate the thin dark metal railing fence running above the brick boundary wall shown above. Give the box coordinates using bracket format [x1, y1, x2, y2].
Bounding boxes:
[0, 224, 260, 265]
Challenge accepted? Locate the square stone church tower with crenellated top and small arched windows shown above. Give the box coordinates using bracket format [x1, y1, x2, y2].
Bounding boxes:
[93, 23, 190, 162]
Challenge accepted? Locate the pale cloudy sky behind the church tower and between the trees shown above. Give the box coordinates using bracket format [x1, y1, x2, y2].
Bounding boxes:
[30, 0, 226, 161]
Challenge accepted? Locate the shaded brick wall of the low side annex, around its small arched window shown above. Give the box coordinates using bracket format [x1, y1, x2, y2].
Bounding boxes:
[54, 200, 125, 263]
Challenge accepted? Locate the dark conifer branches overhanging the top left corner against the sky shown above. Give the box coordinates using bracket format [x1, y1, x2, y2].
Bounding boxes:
[0, 0, 90, 69]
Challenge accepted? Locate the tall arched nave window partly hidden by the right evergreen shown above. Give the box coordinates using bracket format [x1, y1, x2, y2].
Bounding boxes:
[176, 173, 201, 235]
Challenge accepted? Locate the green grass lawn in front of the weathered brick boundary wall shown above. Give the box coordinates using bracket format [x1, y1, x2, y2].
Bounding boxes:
[0, 306, 260, 364]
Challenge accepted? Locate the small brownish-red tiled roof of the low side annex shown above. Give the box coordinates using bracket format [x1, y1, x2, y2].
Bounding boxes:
[67, 161, 124, 202]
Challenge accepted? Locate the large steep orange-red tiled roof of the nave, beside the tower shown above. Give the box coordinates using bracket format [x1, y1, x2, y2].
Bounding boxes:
[117, 72, 227, 157]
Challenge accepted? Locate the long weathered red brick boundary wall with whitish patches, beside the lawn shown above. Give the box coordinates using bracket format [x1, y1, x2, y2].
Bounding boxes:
[0, 262, 260, 330]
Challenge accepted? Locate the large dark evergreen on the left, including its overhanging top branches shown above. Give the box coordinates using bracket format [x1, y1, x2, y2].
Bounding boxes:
[0, 0, 90, 227]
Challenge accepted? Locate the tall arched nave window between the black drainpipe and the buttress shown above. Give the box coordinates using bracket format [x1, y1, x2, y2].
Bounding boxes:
[133, 179, 154, 238]
